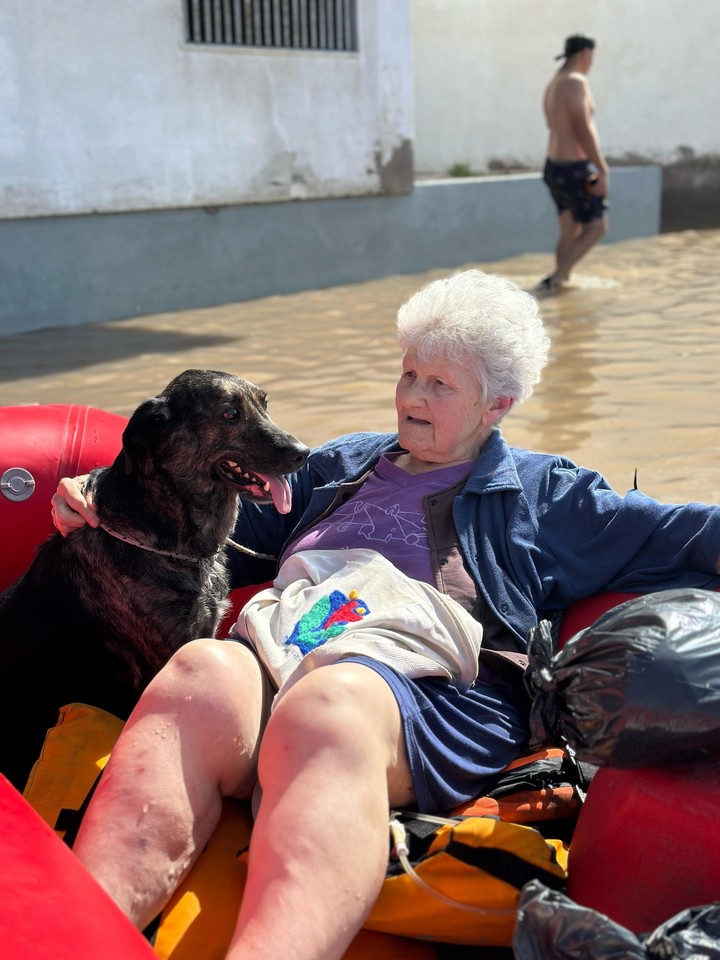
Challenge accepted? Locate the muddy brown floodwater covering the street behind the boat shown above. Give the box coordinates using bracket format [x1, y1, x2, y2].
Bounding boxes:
[0, 230, 720, 503]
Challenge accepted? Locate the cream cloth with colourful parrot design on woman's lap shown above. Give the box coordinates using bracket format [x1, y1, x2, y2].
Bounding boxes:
[235, 549, 482, 699]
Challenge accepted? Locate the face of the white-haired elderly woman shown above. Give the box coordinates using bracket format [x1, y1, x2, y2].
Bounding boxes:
[395, 350, 506, 464]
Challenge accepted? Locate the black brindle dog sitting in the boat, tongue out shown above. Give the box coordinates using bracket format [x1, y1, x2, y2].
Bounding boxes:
[0, 370, 309, 790]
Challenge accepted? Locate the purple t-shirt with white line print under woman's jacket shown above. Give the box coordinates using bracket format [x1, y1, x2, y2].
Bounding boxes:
[282, 454, 472, 586]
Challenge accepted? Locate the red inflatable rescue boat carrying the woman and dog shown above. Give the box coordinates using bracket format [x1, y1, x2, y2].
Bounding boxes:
[0, 404, 720, 960]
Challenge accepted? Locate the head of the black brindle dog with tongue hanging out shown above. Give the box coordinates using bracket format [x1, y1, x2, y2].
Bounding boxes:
[123, 370, 310, 513]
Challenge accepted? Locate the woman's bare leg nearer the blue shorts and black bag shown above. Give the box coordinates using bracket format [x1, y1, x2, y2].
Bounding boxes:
[227, 663, 413, 960]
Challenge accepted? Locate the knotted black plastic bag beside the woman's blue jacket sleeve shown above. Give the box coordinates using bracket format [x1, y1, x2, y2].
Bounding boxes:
[525, 589, 720, 767]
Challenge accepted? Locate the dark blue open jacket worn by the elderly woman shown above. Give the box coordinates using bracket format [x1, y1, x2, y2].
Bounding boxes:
[230, 430, 720, 647]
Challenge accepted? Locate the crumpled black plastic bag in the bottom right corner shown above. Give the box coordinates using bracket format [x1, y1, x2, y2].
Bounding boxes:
[513, 880, 720, 960]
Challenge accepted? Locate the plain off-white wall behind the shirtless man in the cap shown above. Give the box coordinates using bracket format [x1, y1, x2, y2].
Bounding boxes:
[412, 0, 720, 173]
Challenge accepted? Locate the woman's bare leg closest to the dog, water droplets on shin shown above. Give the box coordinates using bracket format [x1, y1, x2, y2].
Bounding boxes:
[74, 640, 268, 929]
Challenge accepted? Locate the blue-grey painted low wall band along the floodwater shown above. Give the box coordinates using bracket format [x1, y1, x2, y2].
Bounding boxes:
[0, 166, 661, 334]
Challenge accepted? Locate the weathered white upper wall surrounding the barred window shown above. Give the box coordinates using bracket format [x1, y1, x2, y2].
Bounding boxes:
[0, 0, 413, 218]
